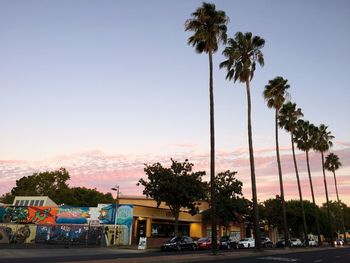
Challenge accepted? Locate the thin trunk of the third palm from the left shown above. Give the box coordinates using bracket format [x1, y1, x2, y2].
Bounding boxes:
[275, 109, 289, 247]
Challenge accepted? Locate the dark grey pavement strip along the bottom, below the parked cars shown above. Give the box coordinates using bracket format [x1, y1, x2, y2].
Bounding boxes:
[0, 247, 346, 263]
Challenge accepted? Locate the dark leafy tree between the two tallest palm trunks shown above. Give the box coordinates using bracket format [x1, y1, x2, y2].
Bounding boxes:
[203, 170, 249, 235]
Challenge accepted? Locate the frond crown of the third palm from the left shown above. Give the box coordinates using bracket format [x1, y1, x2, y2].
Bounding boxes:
[263, 77, 290, 110]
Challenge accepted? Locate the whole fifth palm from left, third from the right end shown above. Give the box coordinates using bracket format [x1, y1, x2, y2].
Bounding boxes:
[294, 119, 322, 246]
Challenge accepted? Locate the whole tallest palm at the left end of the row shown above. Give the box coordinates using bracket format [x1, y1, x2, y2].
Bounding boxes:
[185, 3, 229, 254]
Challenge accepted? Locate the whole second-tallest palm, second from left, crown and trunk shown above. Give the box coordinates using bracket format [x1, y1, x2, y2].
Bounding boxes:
[220, 32, 265, 248]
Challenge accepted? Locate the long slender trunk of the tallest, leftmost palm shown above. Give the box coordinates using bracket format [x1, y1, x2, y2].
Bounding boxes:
[209, 51, 217, 255]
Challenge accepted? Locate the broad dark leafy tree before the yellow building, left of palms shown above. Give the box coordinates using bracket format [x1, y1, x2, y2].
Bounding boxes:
[137, 159, 206, 235]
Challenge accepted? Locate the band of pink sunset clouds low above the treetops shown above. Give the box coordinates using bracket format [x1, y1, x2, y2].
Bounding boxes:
[0, 147, 350, 204]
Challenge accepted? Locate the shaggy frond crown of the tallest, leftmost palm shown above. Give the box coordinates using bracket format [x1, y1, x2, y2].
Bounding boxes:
[185, 3, 229, 53]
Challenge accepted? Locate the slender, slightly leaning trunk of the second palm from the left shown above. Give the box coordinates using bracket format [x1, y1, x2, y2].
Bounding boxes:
[246, 79, 261, 248]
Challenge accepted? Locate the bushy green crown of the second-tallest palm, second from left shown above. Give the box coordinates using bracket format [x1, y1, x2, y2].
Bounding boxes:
[220, 32, 265, 82]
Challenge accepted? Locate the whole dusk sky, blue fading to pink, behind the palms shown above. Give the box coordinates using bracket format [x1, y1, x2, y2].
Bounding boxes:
[0, 0, 350, 205]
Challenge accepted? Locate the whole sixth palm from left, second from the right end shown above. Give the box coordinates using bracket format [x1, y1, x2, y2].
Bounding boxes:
[314, 124, 334, 245]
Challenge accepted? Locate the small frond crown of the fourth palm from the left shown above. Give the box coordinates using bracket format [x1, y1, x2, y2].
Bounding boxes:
[279, 101, 304, 133]
